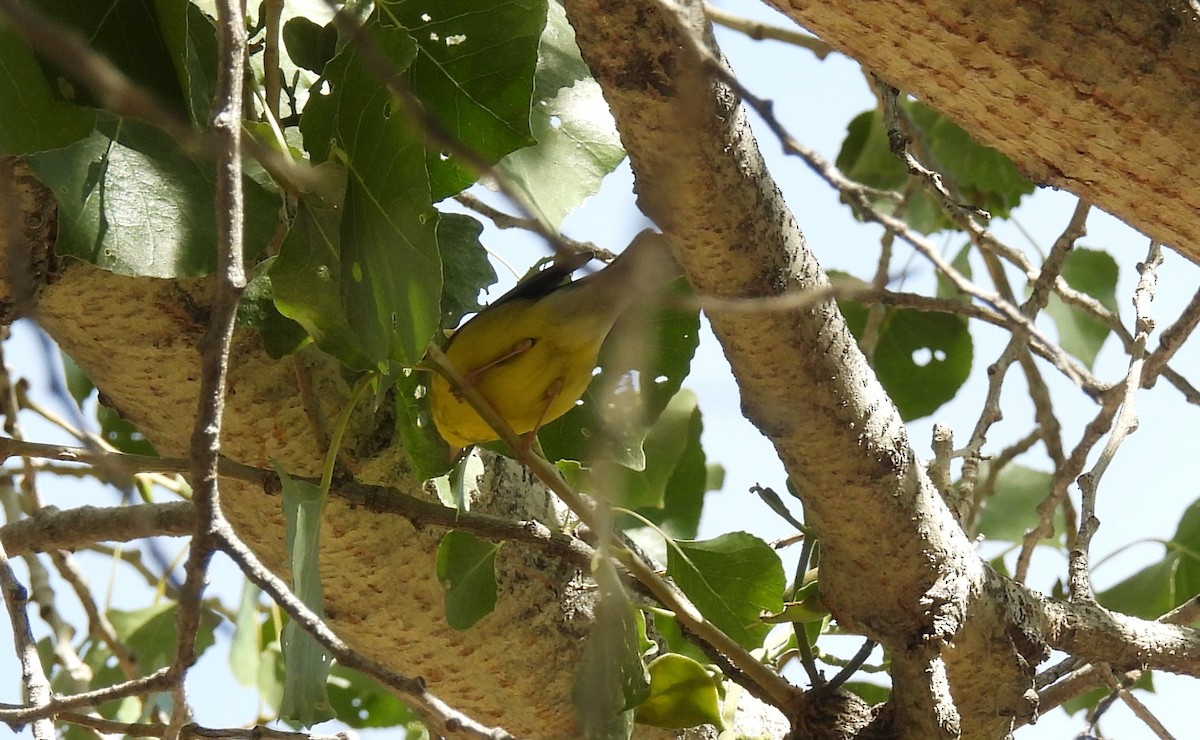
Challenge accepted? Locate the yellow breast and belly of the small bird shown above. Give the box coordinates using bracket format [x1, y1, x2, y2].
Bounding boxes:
[430, 292, 612, 447]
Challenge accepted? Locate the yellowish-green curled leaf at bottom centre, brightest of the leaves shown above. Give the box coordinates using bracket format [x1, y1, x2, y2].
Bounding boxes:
[637, 652, 721, 729]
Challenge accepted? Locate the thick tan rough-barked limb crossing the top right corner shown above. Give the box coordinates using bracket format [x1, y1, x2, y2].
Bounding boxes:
[769, 0, 1200, 261]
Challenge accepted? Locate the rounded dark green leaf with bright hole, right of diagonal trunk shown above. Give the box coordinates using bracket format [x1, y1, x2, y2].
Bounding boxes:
[838, 301, 974, 421]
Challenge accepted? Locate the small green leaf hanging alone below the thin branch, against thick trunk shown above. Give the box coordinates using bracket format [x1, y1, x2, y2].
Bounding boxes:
[438, 530, 500, 630]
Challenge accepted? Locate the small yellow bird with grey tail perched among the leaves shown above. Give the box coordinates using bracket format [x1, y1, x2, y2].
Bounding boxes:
[430, 230, 679, 447]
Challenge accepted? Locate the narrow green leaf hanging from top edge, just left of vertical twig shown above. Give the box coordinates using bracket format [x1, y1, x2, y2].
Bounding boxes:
[154, 0, 217, 128]
